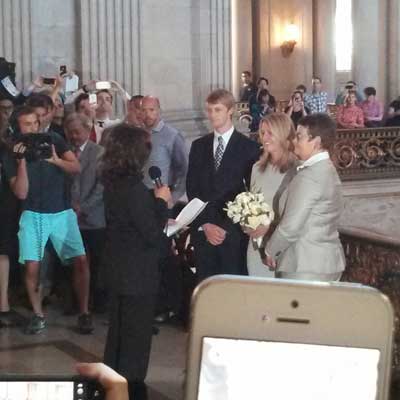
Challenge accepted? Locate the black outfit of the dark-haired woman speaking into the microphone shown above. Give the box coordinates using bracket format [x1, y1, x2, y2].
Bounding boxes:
[104, 176, 168, 384]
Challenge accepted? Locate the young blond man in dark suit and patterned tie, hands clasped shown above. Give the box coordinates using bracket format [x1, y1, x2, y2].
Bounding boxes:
[186, 89, 260, 281]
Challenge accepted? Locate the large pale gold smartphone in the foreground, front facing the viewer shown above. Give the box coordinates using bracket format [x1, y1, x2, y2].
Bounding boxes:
[185, 275, 394, 400]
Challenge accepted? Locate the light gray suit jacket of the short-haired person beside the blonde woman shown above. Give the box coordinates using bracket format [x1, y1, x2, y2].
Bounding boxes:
[266, 159, 345, 274]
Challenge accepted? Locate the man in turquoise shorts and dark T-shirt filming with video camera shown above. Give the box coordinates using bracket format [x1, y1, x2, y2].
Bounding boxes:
[11, 106, 93, 334]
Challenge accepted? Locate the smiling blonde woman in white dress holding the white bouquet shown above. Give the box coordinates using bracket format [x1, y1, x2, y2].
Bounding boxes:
[246, 113, 296, 277]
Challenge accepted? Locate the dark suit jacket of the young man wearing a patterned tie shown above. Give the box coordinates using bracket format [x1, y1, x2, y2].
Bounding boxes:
[186, 130, 260, 230]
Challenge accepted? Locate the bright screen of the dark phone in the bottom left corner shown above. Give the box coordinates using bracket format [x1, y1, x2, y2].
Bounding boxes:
[0, 382, 74, 400]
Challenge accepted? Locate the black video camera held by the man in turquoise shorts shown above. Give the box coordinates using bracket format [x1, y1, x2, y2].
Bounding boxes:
[15, 133, 53, 161]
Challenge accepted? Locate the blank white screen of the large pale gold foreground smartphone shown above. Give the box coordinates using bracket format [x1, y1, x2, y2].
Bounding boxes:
[198, 337, 380, 400]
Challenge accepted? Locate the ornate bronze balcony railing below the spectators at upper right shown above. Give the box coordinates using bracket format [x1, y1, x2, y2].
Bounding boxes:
[332, 127, 400, 180]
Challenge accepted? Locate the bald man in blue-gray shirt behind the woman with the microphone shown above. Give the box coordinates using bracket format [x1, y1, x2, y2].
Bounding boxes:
[142, 96, 188, 203]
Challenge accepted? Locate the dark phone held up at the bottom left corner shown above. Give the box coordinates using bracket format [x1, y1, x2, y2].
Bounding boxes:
[0, 375, 104, 400]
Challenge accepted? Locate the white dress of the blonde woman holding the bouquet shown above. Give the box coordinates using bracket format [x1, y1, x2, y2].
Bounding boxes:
[247, 163, 287, 278]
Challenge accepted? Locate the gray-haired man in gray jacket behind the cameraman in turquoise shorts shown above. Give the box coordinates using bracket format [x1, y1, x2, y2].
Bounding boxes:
[64, 113, 106, 311]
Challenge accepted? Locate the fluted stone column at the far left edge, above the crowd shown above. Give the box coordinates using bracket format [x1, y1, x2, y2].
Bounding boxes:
[0, 0, 32, 86]
